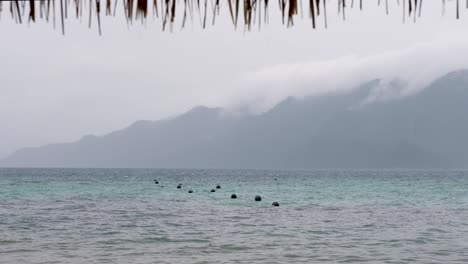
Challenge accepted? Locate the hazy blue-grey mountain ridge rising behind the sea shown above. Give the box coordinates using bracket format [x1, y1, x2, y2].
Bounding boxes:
[0, 71, 468, 168]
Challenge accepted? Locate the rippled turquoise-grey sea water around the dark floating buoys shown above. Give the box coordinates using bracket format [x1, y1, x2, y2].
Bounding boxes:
[0, 169, 468, 263]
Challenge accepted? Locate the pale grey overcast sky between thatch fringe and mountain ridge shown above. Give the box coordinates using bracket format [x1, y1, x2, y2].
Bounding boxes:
[0, 0, 468, 158]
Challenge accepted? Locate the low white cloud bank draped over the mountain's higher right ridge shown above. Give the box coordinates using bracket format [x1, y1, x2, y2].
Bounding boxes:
[230, 31, 468, 112]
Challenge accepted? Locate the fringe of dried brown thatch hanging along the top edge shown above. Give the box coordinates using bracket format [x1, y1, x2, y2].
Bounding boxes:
[0, 0, 468, 34]
